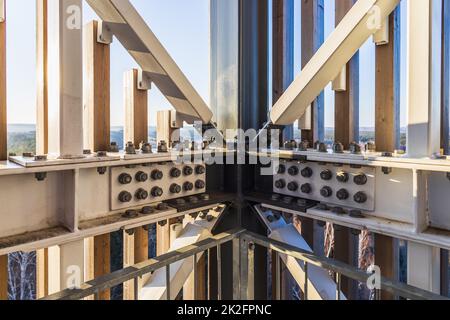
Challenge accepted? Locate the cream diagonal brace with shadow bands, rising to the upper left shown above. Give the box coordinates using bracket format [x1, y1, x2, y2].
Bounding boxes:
[87, 0, 213, 123]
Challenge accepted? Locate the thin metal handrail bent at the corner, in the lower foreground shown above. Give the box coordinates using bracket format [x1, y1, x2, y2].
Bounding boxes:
[43, 229, 448, 300]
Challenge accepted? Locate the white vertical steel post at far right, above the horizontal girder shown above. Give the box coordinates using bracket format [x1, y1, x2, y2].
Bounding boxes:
[406, 0, 442, 158]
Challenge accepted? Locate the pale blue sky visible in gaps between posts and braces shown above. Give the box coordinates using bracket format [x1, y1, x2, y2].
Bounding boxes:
[7, 0, 406, 127]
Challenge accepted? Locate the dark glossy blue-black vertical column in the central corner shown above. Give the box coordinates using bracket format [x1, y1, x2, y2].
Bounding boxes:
[236, 0, 269, 299]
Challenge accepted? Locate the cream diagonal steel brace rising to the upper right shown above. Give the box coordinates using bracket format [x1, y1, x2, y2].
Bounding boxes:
[270, 0, 399, 125]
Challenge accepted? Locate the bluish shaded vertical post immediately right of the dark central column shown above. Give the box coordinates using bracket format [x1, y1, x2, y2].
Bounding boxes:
[272, 0, 294, 141]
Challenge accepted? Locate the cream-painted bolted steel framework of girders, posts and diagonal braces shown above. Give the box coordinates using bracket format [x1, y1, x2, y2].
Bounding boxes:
[0, 0, 450, 300]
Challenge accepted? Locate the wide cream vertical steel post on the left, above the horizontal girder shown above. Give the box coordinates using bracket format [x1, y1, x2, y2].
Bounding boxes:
[48, 0, 83, 158]
